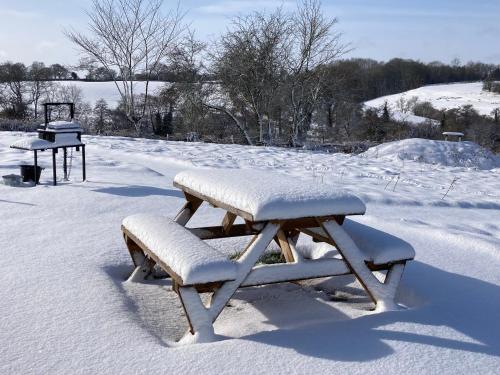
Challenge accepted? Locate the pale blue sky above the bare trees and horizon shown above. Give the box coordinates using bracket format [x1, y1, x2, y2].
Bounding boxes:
[0, 0, 500, 64]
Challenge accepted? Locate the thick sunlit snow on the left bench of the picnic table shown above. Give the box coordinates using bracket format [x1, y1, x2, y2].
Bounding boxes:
[122, 214, 238, 285]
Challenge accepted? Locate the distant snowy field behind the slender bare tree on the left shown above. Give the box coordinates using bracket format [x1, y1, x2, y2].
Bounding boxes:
[59, 81, 165, 108]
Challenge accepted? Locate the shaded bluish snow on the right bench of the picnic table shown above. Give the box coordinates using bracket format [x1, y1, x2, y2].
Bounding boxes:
[298, 219, 415, 266]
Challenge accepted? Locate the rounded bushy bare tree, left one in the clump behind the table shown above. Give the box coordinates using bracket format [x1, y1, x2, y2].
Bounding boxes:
[211, 8, 292, 142]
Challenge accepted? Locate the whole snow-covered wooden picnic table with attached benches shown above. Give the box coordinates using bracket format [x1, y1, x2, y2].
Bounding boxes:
[122, 170, 415, 342]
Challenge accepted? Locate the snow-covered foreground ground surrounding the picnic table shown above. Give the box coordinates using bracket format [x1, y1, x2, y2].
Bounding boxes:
[0, 132, 500, 374]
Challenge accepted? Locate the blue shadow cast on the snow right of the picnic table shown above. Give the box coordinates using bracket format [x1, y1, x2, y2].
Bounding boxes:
[244, 261, 500, 361]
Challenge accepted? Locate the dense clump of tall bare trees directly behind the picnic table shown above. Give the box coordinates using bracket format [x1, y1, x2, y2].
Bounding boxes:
[205, 0, 347, 144]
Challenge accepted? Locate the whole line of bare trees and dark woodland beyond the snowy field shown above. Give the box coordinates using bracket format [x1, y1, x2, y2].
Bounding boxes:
[0, 0, 500, 153]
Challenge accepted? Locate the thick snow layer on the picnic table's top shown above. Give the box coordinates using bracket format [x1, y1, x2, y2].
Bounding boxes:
[174, 169, 366, 221]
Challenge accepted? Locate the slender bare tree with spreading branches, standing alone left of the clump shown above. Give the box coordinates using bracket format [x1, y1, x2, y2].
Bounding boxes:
[66, 0, 183, 133]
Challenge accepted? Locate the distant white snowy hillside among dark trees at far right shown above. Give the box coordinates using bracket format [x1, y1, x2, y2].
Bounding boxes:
[365, 82, 500, 122]
